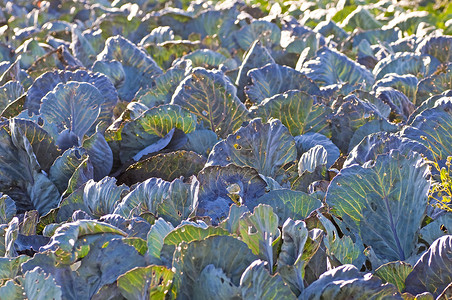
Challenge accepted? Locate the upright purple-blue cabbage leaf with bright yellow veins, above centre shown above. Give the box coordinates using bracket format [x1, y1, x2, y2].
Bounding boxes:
[171, 68, 248, 137]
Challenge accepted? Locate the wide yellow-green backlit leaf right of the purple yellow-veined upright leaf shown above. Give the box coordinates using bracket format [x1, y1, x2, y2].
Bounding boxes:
[251, 91, 332, 136]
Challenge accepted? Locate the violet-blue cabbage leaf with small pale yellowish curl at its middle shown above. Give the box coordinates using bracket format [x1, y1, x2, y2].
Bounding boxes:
[197, 164, 267, 224]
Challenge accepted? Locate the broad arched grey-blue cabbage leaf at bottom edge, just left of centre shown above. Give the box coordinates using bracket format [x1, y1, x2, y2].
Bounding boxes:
[173, 236, 256, 298]
